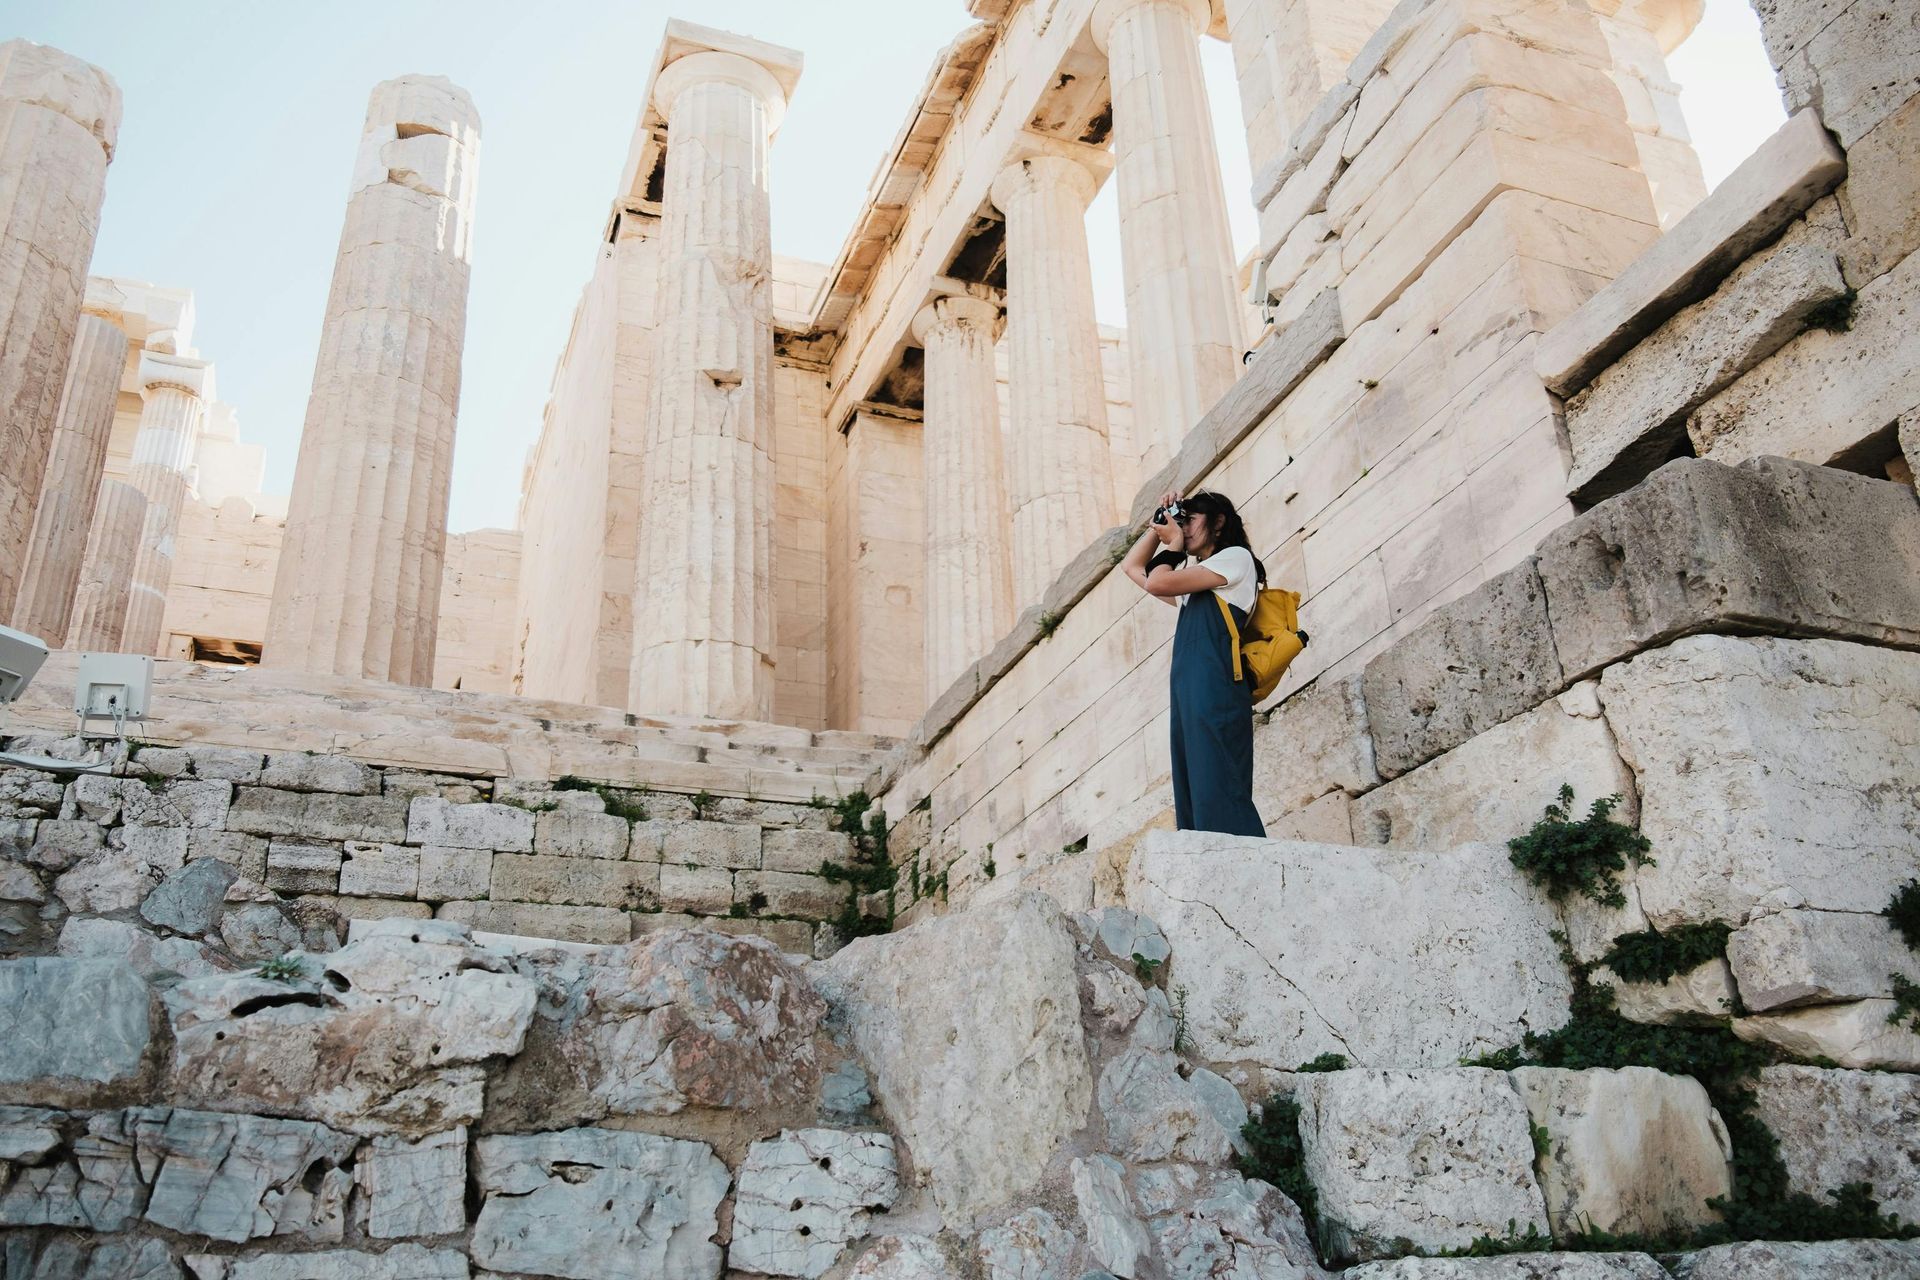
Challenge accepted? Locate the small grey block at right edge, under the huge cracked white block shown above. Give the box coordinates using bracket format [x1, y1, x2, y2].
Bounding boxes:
[1726, 912, 1920, 1013]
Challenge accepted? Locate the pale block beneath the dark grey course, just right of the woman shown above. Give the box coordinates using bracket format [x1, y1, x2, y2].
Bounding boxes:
[1354, 683, 1638, 848]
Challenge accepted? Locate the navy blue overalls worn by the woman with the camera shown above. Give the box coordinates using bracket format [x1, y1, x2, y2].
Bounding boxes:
[1167, 591, 1267, 835]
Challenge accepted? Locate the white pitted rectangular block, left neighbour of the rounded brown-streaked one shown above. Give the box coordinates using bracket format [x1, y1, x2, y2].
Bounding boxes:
[1294, 1067, 1548, 1261]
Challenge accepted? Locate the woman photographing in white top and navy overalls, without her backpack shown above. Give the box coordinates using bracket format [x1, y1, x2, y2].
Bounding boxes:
[1121, 491, 1267, 837]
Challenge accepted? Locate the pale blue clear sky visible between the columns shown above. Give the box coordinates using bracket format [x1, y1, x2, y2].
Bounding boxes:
[15, 0, 1782, 532]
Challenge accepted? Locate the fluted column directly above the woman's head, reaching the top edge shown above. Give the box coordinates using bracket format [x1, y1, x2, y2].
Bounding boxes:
[1092, 0, 1244, 474]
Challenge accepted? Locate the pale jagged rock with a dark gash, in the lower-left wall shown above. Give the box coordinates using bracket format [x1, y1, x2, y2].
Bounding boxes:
[167, 919, 534, 1132]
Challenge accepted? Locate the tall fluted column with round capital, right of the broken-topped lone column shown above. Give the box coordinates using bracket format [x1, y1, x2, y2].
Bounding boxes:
[628, 50, 787, 720]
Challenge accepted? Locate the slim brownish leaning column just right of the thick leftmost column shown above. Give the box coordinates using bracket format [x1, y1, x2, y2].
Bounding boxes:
[13, 315, 127, 645]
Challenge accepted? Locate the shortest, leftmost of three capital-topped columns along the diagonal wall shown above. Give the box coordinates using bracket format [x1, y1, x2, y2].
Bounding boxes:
[914, 296, 1014, 704]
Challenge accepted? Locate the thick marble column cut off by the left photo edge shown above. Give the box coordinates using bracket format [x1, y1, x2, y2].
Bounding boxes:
[0, 40, 121, 618]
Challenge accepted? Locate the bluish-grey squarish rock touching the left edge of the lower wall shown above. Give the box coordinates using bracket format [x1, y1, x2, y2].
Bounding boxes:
[0, 958, 154, 1107]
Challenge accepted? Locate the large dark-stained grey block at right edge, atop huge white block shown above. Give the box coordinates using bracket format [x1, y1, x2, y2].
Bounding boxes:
[1540, 459, 1920, 679]
